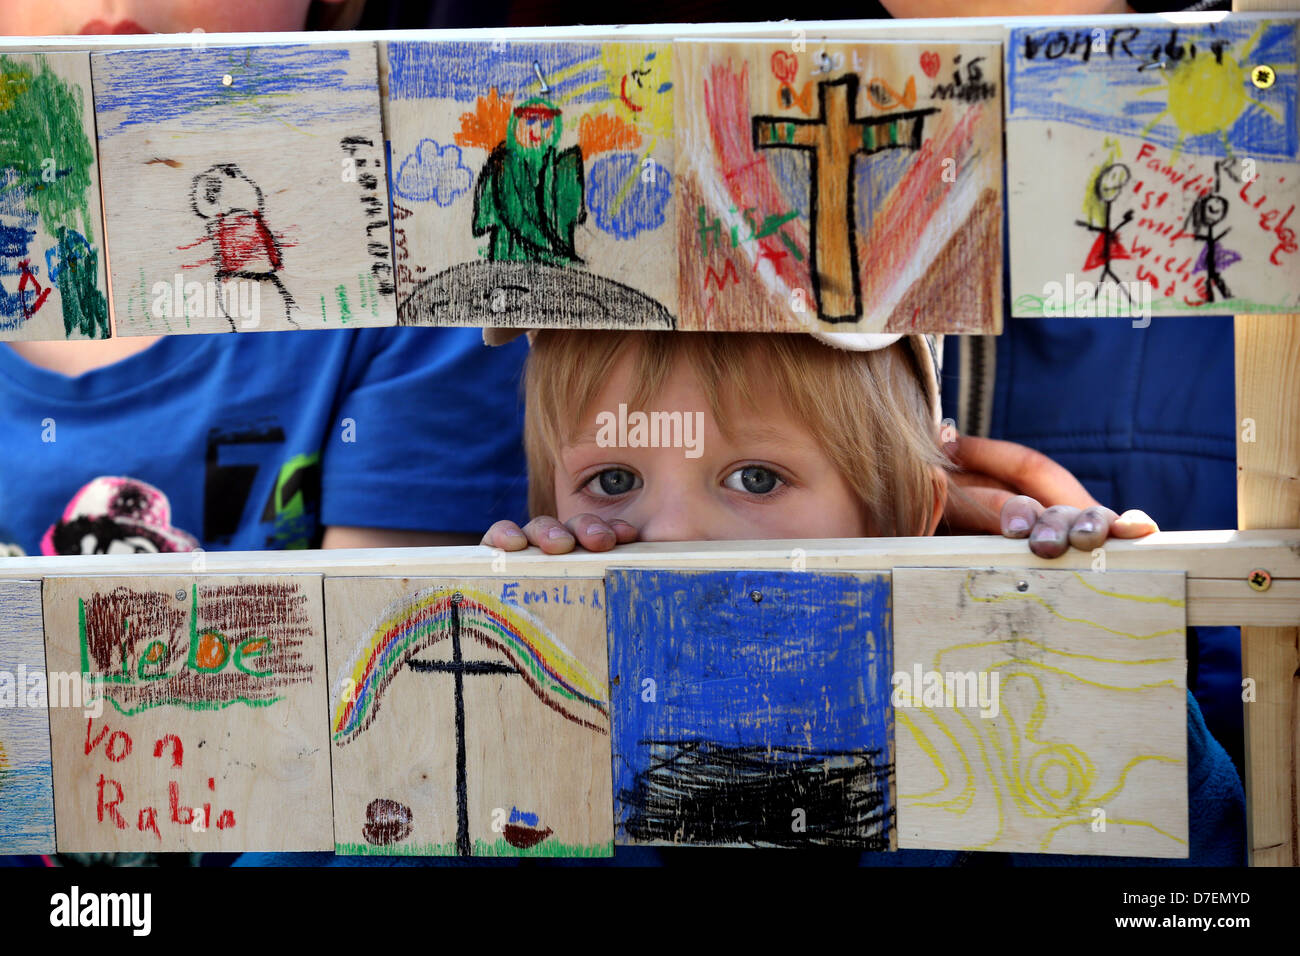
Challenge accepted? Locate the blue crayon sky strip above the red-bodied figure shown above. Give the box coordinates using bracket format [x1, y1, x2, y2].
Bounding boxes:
[95, 46, 380, 138]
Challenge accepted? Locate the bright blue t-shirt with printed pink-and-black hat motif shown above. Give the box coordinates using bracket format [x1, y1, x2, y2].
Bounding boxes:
[0, 328, 528, 554]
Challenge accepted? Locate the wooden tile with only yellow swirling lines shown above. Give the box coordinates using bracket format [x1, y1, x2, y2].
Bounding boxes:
[893, 568, 1188, 857]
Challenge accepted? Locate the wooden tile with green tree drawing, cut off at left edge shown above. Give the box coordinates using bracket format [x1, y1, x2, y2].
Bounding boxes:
[0, 52, 111, 341]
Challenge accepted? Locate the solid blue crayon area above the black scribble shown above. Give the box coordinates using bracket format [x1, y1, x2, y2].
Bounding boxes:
[606, 570, 893, 764]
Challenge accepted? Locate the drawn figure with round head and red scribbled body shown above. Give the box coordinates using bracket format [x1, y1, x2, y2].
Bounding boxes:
[190, 163, 298, 329]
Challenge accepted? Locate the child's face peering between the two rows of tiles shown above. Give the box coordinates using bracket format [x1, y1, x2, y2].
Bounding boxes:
[555, 349, 870, 541]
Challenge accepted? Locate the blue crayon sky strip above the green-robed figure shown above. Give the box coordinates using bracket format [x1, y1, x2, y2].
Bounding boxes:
[389, 40, 612, 104]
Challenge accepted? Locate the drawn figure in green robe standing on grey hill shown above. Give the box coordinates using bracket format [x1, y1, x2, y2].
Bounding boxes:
[473, 98, 586, 265]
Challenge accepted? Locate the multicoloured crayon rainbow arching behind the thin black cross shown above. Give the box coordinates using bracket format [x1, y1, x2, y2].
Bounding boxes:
[330, 587, 610, 744]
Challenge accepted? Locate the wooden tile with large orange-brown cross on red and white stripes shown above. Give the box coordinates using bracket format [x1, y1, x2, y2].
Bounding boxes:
[675, 40, 1002, 333]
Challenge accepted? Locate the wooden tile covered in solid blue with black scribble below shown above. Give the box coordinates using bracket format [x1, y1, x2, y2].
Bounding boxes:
[606, 568, 893, 849]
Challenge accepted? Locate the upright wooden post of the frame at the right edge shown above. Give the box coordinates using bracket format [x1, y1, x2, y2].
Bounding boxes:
[1235, 308, 1300, 866]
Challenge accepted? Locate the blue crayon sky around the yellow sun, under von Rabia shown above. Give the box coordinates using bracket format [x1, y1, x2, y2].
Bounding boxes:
[1008, 20, 1300, 161]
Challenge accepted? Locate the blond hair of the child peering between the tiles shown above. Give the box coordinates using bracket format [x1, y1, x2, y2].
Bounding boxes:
[524, 329, 953, 537]
